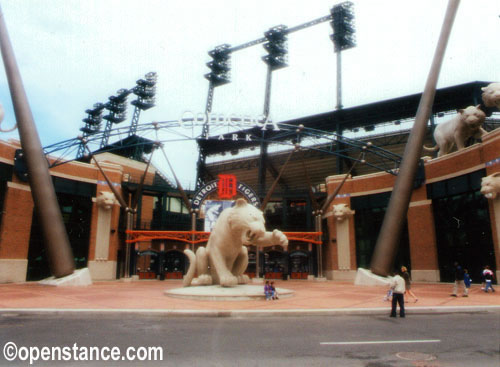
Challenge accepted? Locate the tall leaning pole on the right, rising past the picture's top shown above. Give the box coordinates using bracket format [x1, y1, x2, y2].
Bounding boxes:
[370, 0, 460, 276]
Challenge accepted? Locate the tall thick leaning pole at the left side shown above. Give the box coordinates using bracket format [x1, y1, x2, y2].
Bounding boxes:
[0, 10, 75, 278]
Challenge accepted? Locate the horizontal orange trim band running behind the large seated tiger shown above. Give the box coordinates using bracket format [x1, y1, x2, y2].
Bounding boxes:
[125, 230, 322, 245]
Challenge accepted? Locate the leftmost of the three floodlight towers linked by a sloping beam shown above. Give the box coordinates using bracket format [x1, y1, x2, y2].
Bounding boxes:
[196, 44, 231, 188]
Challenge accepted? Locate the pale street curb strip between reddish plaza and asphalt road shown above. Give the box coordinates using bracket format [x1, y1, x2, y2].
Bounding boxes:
[0, 306, 500, 317]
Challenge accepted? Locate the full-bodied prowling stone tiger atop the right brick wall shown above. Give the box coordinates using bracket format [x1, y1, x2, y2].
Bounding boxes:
[424, 105, 486, 157]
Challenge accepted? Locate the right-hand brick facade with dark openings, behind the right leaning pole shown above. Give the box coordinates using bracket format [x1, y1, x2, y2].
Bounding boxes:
[325, 129, 500, 281]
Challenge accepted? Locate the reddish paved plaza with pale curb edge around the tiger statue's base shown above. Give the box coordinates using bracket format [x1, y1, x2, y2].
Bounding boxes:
[0, 280, 500, 316]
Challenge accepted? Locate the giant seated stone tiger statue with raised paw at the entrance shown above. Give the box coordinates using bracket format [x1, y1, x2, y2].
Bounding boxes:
[183, 199, 288, 287]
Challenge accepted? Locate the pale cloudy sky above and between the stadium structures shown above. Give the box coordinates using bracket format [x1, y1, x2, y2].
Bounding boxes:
[0, 0, 500, 188]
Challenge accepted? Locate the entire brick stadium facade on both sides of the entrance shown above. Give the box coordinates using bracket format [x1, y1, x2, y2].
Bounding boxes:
[0, 129, 500, 283]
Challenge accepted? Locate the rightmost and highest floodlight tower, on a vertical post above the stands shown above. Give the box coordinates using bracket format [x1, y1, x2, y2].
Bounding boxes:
[330, 1, 356, 110]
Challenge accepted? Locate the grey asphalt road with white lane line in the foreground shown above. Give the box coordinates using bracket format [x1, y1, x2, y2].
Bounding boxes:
[0, 312, 500, 367]
